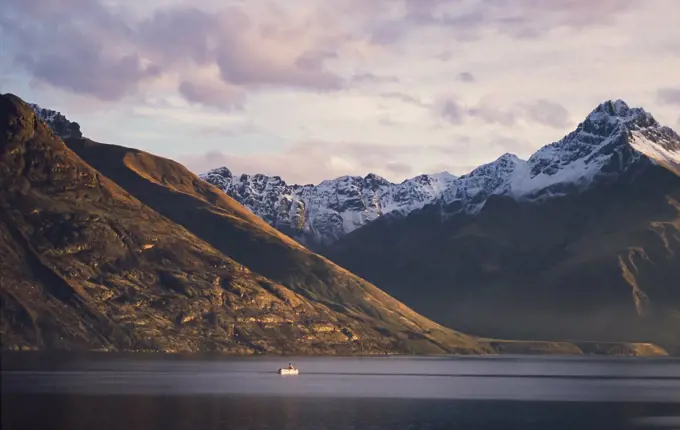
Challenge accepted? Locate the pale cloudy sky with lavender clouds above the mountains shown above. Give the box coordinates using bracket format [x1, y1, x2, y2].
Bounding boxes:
[0, 0, 680, 183]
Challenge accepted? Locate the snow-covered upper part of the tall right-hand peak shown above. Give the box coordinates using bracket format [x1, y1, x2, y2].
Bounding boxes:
[442, 100, 680, 213]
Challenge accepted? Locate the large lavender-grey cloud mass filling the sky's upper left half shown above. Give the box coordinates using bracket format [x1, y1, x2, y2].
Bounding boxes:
[0, 0, 344, 106]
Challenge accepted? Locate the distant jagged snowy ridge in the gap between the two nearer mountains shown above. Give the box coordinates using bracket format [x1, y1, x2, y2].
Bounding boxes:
[201, 167, 456, 248]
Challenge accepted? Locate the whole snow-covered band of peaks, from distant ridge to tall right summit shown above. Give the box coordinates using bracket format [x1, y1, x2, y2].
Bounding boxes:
[202, 100, 680, 245]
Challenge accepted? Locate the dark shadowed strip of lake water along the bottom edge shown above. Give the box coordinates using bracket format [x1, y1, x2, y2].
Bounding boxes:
[2, 394, 678, 430]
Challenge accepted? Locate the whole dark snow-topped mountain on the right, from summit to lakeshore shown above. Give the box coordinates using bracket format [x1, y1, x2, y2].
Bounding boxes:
[325, 101, 680, 353]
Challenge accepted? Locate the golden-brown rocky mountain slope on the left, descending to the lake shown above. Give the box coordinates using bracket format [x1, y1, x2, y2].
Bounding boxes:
[0, 95, 486, 354]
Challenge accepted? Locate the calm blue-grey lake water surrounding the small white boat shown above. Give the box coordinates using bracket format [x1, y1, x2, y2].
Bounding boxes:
[1, 355, 680, 430]
